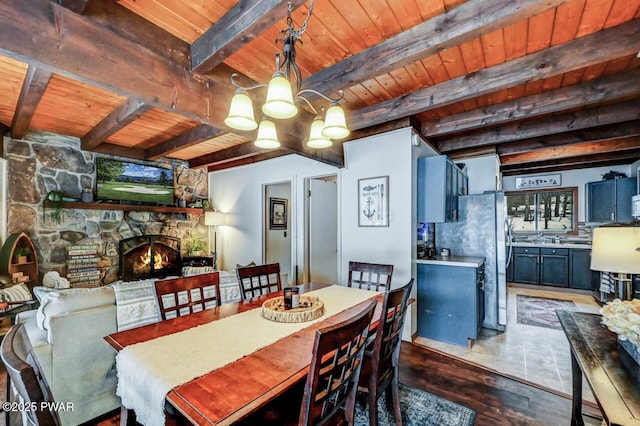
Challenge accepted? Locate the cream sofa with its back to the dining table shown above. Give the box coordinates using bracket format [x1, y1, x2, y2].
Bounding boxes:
[16, 272, 240, 426]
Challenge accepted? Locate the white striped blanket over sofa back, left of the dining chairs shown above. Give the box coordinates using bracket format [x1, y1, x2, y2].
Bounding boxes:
[112, 279, 160, 331]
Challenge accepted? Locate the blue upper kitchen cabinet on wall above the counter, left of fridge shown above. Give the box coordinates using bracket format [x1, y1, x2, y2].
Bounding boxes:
[417, 155, 468, 223]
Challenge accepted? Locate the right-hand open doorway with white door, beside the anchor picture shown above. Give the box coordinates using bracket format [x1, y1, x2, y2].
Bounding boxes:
[305, 175, 338, 283]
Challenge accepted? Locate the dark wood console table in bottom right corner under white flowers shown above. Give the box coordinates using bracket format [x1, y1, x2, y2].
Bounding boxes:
[557, 310, 640, 426]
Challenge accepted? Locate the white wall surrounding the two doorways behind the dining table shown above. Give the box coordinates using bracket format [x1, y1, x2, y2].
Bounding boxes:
[209, 155, 339, 282]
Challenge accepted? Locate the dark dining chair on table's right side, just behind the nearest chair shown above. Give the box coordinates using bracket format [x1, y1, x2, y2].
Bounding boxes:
[358, 278, 413, 426]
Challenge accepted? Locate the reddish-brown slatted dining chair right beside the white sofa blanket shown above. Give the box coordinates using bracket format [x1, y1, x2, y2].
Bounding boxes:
[154, 272, 221, 320]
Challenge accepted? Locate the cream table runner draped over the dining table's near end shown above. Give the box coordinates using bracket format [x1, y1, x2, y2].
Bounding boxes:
[116, 285, 379, 426]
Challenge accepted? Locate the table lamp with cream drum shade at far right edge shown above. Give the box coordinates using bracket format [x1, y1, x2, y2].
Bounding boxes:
[591, 224, 640, 300]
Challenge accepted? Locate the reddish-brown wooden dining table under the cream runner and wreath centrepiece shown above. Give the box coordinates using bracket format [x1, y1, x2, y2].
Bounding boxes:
[104, 283, 383, 425]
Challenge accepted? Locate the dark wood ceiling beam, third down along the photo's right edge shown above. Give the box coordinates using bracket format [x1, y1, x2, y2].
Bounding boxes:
[437, 99, 640, 152]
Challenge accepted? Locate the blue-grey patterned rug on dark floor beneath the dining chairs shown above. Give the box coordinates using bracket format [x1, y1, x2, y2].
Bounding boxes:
[354, 383, 476, 426]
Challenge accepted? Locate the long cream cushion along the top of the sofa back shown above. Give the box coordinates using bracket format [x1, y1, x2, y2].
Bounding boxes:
[36, 287, 116, 330]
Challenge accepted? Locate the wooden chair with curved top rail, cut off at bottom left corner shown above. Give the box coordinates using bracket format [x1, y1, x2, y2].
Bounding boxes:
[0, 323, 60, 426]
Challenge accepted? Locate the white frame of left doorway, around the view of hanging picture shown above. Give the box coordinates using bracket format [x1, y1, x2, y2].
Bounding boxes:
[260, 176, 298, 284]
